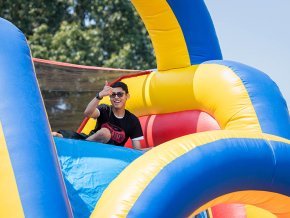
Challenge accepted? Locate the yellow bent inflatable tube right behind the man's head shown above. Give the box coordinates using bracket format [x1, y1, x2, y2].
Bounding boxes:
[96, 64, 261, 132]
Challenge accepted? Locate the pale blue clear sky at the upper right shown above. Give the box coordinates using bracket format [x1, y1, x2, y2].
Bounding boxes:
[205, 0, 290, 109]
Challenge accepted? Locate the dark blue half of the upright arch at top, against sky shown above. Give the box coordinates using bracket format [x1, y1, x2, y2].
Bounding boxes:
[167, 0, 222, 65]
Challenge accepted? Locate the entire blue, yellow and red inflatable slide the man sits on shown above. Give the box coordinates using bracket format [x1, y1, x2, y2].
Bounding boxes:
[0, 0, 290, 218]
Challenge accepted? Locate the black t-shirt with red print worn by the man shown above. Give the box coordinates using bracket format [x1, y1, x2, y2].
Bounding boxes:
[94, 104, 143, 145]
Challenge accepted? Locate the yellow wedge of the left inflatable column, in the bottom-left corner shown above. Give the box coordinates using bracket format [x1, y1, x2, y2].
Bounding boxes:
[0, 122, 24, 218]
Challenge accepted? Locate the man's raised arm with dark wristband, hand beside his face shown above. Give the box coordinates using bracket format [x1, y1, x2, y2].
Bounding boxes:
[84, 81, 113, 119]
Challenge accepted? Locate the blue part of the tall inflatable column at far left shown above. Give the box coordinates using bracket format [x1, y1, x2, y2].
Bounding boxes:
[0, 18, 71, 217]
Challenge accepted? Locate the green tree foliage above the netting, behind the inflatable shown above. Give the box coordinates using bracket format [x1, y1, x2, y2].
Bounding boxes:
[0, 0, 156, 69]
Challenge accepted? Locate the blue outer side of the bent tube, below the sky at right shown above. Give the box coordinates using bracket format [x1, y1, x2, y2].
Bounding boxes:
[205, 61, 290, 139]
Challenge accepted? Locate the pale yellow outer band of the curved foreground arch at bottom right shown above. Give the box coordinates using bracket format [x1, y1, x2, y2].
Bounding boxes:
[91, 130, 290, 218]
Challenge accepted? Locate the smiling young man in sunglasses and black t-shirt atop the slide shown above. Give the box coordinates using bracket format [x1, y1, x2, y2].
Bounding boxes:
[84, 82, 144, 149]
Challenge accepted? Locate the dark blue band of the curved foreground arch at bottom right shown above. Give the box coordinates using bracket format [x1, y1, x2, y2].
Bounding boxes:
[128, 138, 290, 217]
